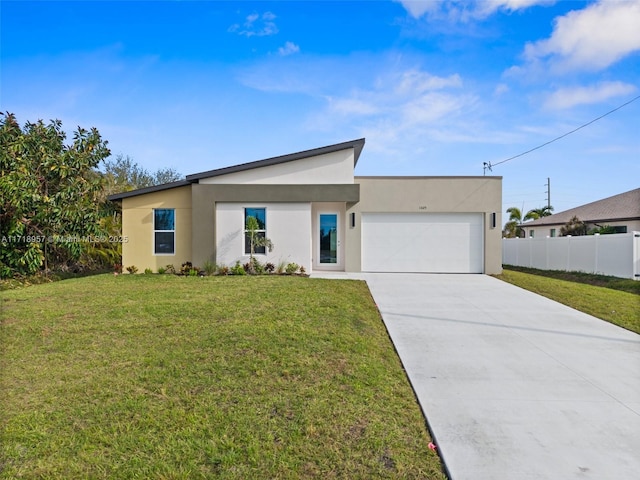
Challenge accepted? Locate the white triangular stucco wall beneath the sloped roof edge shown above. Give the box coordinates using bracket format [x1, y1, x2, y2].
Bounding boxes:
[200, 148, 354, 185]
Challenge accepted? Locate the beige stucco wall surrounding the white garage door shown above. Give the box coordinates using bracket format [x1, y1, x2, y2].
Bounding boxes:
[345, 177, 502, 274]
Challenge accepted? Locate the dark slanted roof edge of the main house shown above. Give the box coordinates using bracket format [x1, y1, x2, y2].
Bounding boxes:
[107, 138, 365, 201]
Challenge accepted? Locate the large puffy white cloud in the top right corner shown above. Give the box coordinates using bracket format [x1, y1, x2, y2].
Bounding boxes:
[525, 0, 640, 70]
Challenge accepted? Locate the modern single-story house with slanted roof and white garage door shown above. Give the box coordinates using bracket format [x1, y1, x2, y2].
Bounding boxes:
[109, 139, 502, 274]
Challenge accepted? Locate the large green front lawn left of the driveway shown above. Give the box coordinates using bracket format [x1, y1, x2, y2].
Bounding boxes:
[0, 275, 445, 479]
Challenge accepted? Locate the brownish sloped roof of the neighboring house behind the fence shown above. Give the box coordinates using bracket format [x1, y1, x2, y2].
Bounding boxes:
[523, 188, 640, 227]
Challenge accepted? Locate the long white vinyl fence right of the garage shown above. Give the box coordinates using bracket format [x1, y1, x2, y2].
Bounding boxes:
[502, 232, 640, 280]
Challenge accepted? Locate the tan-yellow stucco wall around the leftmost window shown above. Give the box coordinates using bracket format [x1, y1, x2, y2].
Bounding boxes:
[122, 186, 191, 273]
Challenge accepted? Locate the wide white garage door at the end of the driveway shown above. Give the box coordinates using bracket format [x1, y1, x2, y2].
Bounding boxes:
[362, 213, 484, 273]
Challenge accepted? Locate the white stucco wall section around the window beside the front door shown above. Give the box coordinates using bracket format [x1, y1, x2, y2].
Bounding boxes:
[215, 202, 311, 271]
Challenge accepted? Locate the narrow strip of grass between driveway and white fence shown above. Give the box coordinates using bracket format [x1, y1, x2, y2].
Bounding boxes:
[496, 267, 640, 333]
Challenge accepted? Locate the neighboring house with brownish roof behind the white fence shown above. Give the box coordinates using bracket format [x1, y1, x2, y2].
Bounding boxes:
[522, 188, 640, 238]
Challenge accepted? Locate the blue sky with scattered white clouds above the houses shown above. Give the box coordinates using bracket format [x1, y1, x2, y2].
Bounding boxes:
[0, 0, 640, 212]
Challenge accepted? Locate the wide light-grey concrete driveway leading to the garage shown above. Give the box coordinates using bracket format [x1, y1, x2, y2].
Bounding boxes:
[359, 274, 640, 480]
